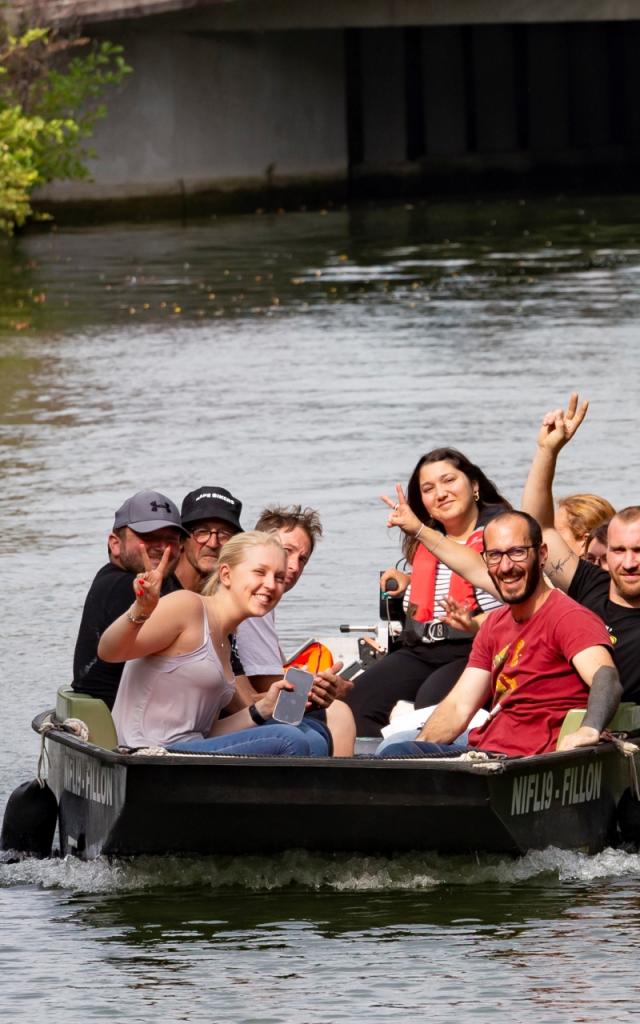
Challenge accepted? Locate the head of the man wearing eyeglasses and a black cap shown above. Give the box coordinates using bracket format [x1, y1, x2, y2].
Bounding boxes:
[175, 486, 243, 593]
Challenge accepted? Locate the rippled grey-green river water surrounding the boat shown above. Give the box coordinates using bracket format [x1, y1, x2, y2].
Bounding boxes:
[0, 197, 640, 1024]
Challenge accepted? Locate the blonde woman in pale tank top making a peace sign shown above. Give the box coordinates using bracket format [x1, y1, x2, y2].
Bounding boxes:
[98, 530, 329, 757]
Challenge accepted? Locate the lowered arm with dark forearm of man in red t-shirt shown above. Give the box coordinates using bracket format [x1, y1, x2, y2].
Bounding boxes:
[558, 647, 623, 751]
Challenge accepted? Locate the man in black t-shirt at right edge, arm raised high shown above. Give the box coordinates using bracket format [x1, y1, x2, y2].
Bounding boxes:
[522, 395, 640, 703]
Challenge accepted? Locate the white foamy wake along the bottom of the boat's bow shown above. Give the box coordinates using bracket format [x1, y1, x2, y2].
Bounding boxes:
[0, 848, 640, 894]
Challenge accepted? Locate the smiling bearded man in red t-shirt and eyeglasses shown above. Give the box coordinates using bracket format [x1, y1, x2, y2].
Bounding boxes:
[383, 512, 622, 758]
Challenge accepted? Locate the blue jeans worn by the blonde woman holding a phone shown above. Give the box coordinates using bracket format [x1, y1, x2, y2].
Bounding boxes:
[167, 722, 328, 758]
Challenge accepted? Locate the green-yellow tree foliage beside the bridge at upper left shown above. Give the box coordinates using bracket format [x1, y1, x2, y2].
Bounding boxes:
[0, 15, 131, 234]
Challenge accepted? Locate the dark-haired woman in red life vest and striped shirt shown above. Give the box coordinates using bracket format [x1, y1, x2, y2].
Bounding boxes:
[346, 447, 511, 736]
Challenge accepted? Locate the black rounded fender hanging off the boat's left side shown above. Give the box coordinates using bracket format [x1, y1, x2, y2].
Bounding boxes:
[0, 778, 57, 859]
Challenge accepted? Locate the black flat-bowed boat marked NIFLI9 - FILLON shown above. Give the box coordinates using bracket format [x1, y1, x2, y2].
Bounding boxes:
[26, 688, 640, 859]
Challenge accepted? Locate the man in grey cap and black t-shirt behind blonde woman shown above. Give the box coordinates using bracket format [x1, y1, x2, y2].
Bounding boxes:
[72, 490, 186, 709]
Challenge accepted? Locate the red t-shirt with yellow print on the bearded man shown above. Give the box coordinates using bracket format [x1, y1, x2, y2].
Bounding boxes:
[467, 590, 611, 756]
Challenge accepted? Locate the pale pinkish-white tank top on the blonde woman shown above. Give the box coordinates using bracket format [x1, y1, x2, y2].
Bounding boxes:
[113, 602, 236, 746]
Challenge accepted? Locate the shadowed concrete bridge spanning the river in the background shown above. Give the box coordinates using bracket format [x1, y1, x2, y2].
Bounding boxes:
[8, 0, 640, 215]
